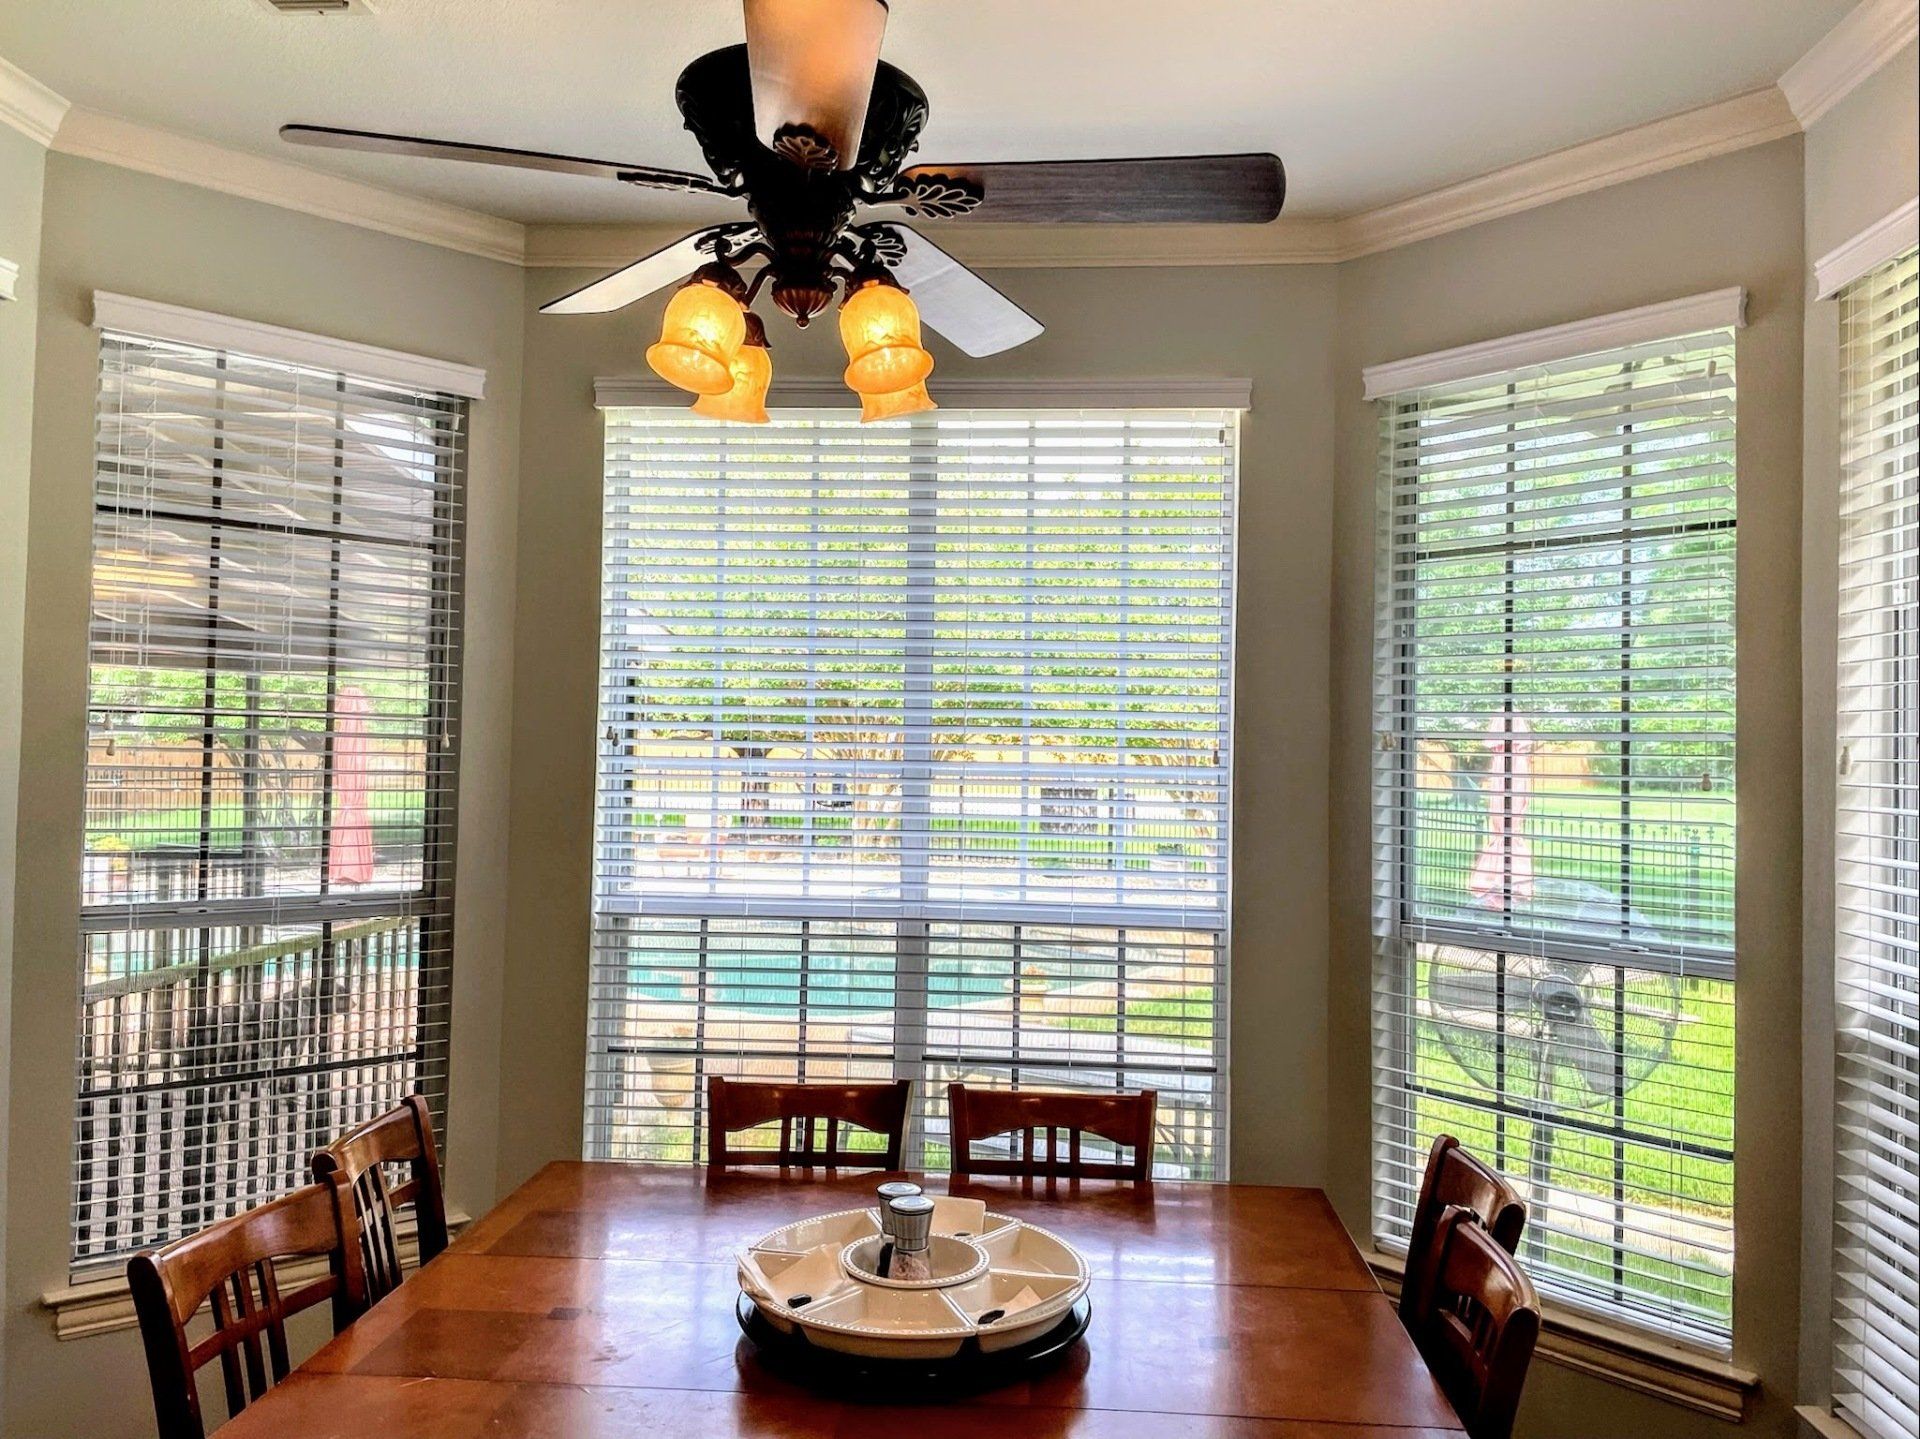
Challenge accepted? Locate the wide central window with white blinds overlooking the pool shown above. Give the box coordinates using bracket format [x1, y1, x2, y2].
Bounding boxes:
[586, 409, 1236, 1178]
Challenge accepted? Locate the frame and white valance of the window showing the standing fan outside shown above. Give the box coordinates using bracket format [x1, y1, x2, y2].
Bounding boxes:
[1367, 309, 1743, 1354]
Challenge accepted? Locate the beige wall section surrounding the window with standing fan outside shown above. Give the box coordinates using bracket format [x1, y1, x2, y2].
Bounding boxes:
[1329, 138, 1803, 1439]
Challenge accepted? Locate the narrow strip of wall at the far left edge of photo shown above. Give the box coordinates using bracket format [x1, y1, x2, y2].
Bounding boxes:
[0, 115, 46, 1429]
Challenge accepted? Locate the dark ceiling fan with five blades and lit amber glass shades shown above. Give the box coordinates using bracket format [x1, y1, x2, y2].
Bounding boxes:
[280, 0, 1286, 423]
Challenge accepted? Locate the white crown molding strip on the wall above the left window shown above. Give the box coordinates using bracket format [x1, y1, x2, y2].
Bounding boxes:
[54, 106, 526, 265]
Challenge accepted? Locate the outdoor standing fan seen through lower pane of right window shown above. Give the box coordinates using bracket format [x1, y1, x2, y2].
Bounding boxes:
[1421, 945, 1684, 1233]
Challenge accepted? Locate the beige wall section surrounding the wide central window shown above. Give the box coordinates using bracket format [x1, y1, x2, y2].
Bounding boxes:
[499, 257, 1334, 1185]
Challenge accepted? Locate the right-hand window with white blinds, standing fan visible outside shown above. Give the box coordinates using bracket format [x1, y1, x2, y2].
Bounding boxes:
[1373, 305, 1738, 1349]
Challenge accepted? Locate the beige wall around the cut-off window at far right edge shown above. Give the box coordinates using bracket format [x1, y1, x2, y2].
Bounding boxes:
[1801, 36, 1920, 1404]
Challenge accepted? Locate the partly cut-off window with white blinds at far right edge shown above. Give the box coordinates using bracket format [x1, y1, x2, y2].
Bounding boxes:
[1834, 243, 1920, 1439]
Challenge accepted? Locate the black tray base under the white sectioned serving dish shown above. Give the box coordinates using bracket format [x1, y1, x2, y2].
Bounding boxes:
[733, 1295, 1092, 1404]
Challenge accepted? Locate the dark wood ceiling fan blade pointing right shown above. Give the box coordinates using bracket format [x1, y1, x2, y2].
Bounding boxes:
[895, 156, 1286, 225]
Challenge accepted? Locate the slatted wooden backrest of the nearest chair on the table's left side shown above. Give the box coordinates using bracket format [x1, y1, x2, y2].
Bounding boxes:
[127, 1182, 367, 1439]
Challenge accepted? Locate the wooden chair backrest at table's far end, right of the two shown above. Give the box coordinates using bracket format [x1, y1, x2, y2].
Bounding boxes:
[947, 1084, 1160, 1182]
